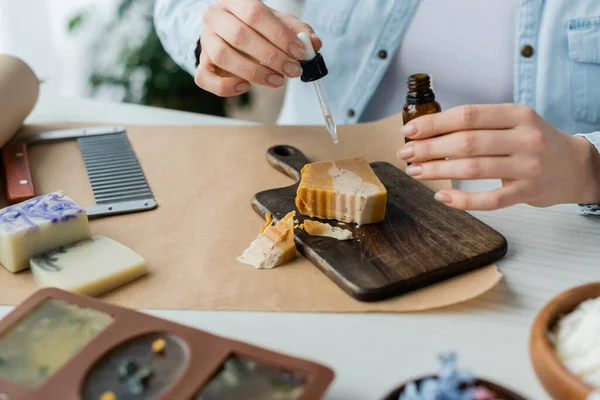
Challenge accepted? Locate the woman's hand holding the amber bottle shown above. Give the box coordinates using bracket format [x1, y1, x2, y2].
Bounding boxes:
[398, 104, 600, 210]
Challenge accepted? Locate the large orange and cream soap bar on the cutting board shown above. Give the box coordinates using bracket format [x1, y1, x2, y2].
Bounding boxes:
[296, 157, 387, 225]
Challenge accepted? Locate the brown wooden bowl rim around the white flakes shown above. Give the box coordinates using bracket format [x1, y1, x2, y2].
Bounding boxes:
[529, 282, 600, 400]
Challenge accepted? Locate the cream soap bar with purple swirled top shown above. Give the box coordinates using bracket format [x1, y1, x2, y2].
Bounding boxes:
[0, 192, 91, 272]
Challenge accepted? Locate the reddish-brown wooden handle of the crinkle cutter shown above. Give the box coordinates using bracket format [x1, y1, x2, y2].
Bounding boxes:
[2, 141, 35, 205]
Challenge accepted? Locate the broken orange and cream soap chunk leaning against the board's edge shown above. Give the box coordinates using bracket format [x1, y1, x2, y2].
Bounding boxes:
[237, 211, 296, 269]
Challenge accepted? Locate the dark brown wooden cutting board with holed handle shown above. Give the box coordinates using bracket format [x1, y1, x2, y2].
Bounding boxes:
[252, 145, 507, 301]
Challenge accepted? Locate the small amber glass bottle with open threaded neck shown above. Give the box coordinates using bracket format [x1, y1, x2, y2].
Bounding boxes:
[402, 74, 442, 141]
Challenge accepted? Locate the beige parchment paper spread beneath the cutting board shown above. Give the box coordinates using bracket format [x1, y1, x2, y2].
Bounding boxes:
[0, 111, 502, 312]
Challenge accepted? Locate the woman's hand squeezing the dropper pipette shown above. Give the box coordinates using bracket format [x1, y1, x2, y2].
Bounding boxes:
[195, 0, 321, 97]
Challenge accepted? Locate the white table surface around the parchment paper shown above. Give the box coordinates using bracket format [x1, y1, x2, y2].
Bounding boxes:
[0, 88, 600, 400]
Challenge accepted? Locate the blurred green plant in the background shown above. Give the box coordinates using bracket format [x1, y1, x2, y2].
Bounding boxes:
[67, 0, 250, 116]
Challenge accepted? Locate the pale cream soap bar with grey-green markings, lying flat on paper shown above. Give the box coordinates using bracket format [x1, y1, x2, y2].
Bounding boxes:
[30, 235, 147, 296]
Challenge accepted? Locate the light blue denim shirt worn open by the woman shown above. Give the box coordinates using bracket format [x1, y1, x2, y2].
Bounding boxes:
[155, 0, 600, 211]
